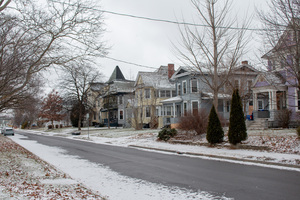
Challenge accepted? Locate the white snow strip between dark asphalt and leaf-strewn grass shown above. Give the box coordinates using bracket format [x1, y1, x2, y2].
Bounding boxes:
[13, 135, 228, 200]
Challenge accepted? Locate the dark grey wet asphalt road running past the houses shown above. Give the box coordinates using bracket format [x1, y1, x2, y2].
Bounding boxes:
[15, 132, 300, 200]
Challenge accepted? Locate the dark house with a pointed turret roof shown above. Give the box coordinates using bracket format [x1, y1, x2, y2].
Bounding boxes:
[100, 66, 134, 127]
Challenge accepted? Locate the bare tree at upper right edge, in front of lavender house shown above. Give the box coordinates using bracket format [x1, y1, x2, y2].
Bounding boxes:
[258, 0, 300, 88]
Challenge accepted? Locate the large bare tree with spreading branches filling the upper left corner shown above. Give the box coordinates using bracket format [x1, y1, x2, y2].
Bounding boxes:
[0, 0, 107, 111]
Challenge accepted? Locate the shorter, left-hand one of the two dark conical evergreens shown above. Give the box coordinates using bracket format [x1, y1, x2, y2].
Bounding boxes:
[206, 105, 224, 144]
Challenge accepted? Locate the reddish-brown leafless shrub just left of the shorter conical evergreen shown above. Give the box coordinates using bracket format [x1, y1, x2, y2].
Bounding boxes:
[178, 109, 208, 135]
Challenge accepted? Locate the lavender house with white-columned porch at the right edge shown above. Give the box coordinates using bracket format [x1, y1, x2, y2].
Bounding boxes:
[252, 21, 300, 127]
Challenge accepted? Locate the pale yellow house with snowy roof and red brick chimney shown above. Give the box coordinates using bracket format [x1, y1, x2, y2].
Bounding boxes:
[130, 64, 176, 128]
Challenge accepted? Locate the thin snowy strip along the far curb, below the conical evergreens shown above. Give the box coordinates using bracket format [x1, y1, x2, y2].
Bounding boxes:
[128, 145, 300, 169]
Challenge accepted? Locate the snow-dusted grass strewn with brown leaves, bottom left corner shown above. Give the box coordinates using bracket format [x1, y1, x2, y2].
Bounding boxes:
[0, 136, 102, 200]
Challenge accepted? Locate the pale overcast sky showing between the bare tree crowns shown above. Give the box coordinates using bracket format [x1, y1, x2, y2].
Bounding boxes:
[99, 0, 267, 79]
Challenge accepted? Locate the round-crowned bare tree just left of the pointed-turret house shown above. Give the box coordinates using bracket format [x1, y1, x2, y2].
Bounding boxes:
[59, 63, 101, 130]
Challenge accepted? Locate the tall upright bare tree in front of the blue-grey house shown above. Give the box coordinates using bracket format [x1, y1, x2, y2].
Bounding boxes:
[174, 0, 249, 108]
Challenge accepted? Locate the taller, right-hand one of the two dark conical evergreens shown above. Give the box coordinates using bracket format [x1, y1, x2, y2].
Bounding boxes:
[228, 89, 247, 145]
